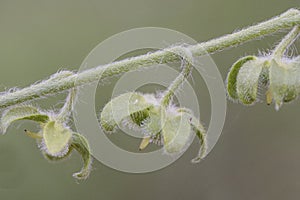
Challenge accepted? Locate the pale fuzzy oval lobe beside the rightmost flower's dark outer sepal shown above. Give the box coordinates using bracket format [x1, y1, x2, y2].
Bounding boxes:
[236, 59, 265, 105]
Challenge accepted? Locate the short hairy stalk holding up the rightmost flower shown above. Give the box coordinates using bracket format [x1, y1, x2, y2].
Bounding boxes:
[273, 26, 300, 59]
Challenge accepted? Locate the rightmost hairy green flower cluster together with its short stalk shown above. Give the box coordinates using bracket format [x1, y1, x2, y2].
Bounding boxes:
[227, 26, 300, 110]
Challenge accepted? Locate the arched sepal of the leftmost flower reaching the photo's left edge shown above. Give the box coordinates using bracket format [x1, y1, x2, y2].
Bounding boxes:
[0, 105, 49, 134]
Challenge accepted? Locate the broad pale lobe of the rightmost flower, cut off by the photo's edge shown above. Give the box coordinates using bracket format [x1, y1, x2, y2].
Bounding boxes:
[270, 59, 300, 110]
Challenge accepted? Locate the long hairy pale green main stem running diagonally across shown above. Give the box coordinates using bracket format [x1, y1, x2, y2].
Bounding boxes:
[0, 9, 300, 108]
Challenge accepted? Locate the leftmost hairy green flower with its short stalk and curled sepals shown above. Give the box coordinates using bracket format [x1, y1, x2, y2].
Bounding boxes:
[0, 89, 92, 179]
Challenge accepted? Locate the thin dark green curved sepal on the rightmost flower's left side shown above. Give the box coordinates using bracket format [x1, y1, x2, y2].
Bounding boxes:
[227, 56, 256, 100]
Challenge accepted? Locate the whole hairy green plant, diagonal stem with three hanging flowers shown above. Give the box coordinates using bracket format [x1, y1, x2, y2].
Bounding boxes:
[0, 9, 300, 179]
